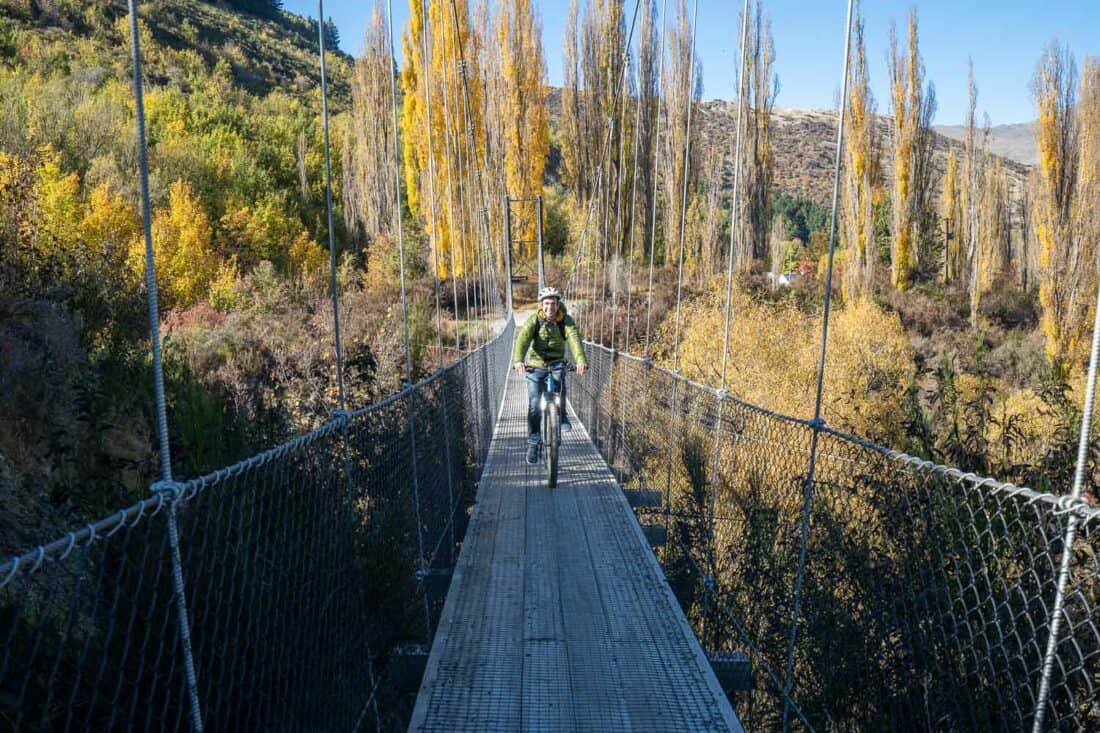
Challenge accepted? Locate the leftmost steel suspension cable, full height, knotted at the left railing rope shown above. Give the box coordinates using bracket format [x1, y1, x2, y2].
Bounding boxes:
[129, 0, 202, 733]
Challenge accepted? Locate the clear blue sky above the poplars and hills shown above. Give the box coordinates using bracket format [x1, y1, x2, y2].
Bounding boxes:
[284, 0, 1100, 124]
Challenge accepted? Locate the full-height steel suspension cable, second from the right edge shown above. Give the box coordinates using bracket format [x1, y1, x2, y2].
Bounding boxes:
[783, 0, 853, 732]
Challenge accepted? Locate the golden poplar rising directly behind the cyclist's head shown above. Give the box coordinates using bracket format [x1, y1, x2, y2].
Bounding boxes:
[497, 0, 550, 255]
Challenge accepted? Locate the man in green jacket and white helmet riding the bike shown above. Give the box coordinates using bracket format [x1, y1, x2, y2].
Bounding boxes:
[512, 287, 589, 464]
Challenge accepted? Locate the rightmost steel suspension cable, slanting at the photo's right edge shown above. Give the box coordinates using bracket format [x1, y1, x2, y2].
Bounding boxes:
[1032, 277, 1100, 733]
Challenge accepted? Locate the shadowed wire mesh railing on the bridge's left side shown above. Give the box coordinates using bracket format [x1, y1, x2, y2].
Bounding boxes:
[0, 319, 514, 731]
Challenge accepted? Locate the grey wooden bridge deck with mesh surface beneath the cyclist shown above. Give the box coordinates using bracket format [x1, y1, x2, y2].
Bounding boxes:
[409, 363, 741, 733]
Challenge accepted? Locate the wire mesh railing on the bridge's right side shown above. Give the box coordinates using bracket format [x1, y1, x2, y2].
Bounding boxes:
[570, 343, 1100, 730]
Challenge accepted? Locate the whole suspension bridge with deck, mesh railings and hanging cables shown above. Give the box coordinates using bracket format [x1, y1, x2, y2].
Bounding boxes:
[0, 2, 1100, 731]
